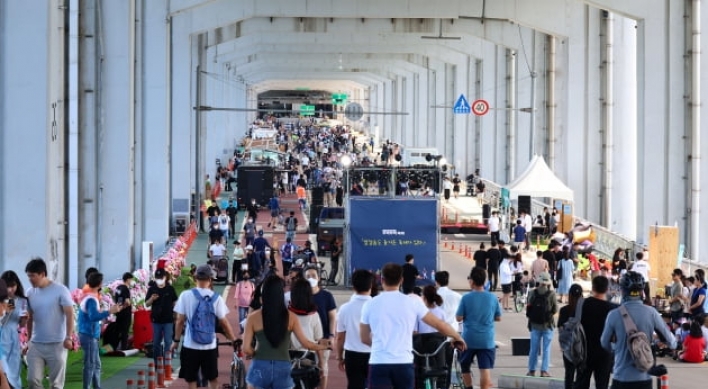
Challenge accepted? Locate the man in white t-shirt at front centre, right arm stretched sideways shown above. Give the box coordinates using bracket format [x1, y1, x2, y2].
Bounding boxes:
[359, 263, 466, 389]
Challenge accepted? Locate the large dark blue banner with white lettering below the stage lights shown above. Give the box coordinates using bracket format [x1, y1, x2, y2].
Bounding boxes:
[348, 196, 440, 279]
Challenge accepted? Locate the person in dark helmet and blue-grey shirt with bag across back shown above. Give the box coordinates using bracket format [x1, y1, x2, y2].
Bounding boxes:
[600, 271, 676, 389]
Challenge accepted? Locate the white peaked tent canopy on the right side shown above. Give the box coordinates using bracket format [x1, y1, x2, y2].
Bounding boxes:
[506, 155, 573, 201]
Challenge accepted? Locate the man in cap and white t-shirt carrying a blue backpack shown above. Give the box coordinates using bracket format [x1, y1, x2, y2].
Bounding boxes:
[169, 265, 236, 389]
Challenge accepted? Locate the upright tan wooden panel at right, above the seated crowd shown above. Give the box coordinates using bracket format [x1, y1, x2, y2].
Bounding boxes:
[649, 226, 679, 297]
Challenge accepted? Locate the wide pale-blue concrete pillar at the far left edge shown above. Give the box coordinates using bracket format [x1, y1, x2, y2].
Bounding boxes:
[0, 2, 68, 282]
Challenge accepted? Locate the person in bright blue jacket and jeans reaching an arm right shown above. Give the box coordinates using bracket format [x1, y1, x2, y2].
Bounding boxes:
[77, 272, 127, 389]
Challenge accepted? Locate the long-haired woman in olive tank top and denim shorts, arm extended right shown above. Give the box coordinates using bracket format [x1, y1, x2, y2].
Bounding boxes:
[243, 276, 330, 389]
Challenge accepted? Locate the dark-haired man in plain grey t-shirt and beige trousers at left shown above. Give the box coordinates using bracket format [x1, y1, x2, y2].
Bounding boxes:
[25, 258, 74, 389]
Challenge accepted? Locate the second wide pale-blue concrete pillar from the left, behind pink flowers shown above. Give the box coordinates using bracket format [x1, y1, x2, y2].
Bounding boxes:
[96, 1, 139, 274]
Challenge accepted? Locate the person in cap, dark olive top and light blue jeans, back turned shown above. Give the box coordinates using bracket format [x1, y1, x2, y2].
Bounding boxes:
[526, 272, 558, 377]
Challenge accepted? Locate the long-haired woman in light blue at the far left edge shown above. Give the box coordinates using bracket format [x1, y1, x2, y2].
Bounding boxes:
[0, 270, 27, 388]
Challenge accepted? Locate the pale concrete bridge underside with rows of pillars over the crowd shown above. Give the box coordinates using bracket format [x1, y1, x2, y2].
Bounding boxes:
[0, 0, 708, 286]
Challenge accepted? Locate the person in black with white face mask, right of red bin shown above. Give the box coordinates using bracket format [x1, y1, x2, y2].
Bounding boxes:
[145, 269, 181, 366]
